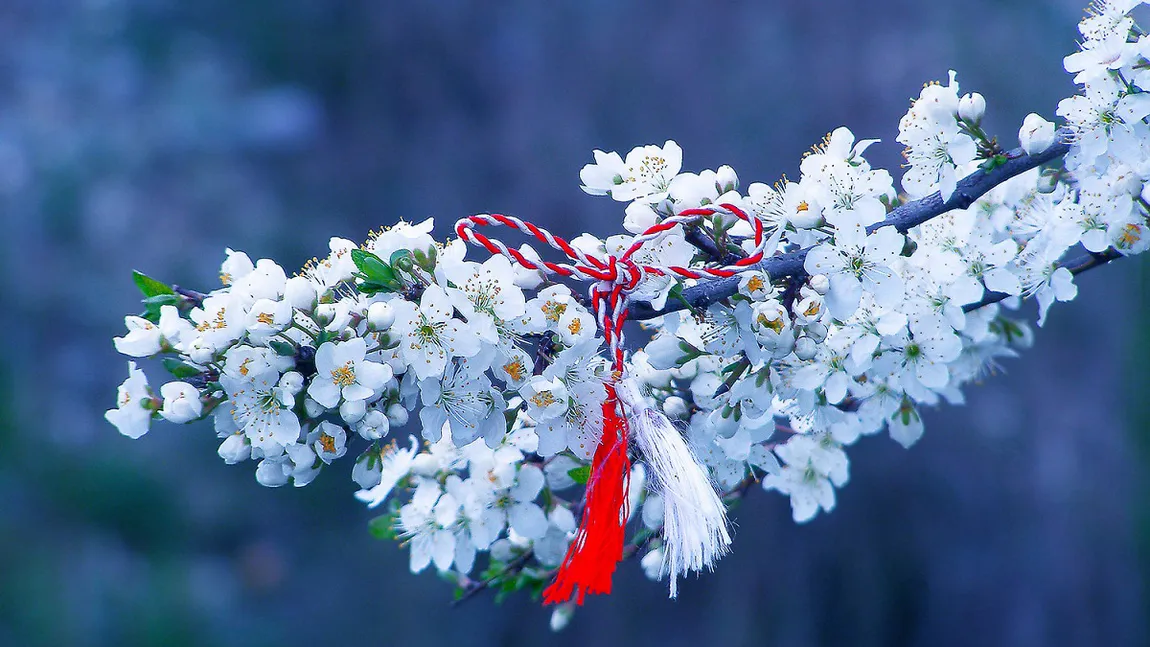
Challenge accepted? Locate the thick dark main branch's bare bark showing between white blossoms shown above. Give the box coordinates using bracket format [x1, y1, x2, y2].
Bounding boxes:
[628, 129, 1071, 321]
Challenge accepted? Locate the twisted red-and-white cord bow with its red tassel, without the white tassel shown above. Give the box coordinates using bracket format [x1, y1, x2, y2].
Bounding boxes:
[455, 203, 768, 604]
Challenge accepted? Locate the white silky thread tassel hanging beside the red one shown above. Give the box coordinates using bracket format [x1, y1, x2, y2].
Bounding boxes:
[616, 379, 730, 598]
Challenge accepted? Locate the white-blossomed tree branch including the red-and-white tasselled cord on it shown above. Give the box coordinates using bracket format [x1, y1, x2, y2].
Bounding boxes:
[107, 0, 1150, 625]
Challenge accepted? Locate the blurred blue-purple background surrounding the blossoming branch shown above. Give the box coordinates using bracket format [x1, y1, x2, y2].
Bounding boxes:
[0, 0, 1150, 647]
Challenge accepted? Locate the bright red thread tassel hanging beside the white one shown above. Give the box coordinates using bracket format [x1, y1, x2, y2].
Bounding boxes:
[543, 383, 631, 604]
